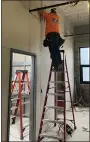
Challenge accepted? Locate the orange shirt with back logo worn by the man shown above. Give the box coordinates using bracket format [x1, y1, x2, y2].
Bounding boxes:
[41, 11, 60, 35]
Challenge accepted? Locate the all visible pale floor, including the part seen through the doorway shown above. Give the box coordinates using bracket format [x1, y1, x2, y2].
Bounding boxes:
[10, 108, 89, 142]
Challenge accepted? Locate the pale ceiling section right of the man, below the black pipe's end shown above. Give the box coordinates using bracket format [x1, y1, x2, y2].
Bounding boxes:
[60, 2, 89, 26]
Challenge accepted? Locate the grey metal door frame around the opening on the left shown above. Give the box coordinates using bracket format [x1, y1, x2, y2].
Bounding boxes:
[7, 48, 36, 142]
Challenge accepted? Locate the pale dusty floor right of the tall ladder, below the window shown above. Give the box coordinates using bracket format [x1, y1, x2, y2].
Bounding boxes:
[64, 108, 90, 142]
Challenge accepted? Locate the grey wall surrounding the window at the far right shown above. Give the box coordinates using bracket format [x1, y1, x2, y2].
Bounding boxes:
[74, 25, 90, 102]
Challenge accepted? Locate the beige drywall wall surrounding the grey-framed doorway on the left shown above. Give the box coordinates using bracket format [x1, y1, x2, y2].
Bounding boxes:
[2, 1, 40, 141]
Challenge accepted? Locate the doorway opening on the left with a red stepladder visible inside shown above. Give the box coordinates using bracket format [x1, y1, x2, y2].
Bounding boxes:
[8, 50, 36, 141]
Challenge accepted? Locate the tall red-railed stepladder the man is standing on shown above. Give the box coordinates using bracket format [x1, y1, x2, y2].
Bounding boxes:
[37, 50, 76, 142]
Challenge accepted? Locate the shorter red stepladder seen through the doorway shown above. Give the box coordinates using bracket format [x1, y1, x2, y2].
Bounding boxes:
[11, 70, 30, 140]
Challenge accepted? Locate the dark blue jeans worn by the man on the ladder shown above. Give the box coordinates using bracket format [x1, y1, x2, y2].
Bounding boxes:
[46, 33, 64, 70]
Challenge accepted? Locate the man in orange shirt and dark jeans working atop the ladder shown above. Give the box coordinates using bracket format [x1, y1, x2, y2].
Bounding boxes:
[38, 8, 65, 71]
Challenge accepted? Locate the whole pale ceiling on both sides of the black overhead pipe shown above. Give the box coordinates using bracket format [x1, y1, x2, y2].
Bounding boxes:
[23, 0, 89, 26]
